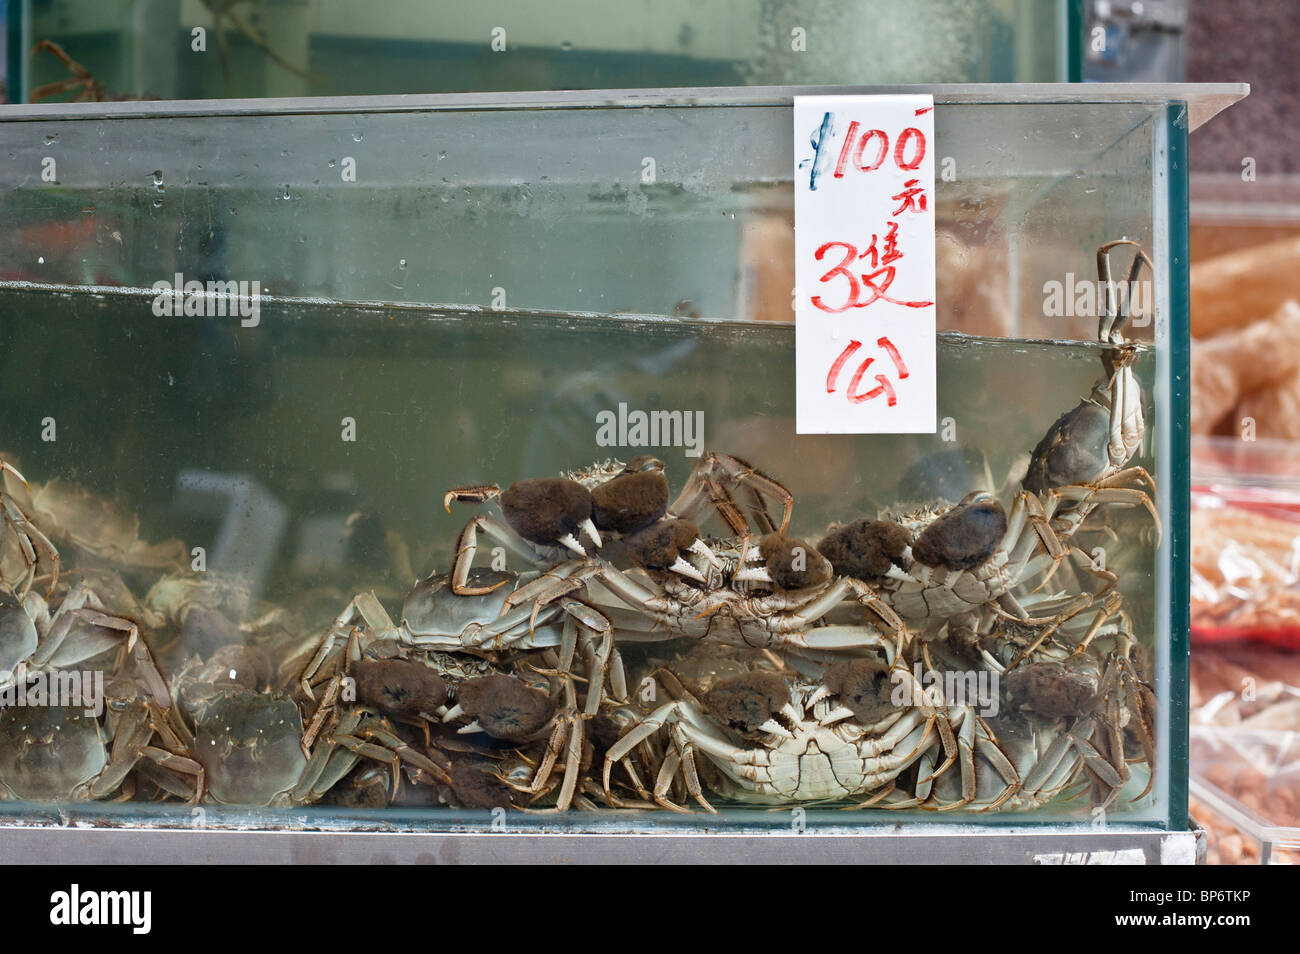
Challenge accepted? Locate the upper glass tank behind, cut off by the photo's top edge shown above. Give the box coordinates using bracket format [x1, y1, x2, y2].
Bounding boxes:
[8, 0, 1083, 103]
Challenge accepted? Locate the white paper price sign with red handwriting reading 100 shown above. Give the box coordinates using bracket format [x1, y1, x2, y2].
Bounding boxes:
[794, 95, 936, 434]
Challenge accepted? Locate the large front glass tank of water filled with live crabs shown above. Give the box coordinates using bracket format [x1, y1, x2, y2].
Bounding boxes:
[0, 86, 1243, 831]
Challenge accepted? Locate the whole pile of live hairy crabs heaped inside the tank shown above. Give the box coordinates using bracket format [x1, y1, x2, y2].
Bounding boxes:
[0, 243, 1158, 811]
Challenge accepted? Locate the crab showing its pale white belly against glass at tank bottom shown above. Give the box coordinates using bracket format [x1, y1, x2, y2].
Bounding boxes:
[603, 638, 977, 811]
